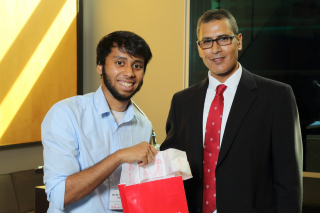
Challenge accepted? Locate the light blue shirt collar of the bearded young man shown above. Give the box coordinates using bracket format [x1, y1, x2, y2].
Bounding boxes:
[94, 85, 140, 123]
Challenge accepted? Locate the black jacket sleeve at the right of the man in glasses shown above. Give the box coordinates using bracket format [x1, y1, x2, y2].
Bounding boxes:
[272, 86, 303, 213]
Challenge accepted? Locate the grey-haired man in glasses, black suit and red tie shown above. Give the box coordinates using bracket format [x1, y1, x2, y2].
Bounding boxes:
[160, 9, 302, 213]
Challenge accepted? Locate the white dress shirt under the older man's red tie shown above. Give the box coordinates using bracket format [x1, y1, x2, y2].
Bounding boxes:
[202, 63, 242, 213]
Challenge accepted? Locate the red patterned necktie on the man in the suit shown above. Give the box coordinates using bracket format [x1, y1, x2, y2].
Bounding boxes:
[202, 84, 227, 213]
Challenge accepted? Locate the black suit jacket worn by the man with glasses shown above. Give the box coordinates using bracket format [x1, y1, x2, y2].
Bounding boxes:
[161, 68, 302, 213]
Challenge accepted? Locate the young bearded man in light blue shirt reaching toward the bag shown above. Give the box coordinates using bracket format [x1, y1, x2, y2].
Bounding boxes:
[41, 31, 157, 213]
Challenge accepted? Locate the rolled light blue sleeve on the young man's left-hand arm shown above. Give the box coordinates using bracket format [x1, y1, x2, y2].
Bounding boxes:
[41, 104, 80, 210]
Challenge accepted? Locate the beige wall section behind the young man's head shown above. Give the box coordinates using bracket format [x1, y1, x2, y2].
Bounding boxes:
[84, 0, 186, 143]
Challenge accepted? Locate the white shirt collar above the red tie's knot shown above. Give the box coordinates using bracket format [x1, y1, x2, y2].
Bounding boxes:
[208, 62, 242, 92]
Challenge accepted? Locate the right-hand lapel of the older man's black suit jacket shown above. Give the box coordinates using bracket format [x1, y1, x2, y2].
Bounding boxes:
[217, 68, 257, 167]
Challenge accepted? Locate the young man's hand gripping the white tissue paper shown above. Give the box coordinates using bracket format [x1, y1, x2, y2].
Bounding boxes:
[118, 141, 157, 166]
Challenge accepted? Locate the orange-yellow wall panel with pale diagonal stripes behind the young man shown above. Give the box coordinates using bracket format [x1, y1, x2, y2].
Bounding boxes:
[0, 0, 77, 146]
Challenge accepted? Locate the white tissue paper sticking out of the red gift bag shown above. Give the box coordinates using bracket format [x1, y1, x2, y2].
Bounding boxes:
[120, 149, 192, 186]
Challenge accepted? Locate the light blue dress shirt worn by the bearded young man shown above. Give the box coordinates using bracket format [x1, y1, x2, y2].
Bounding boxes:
[41, 86, 152, 213]
